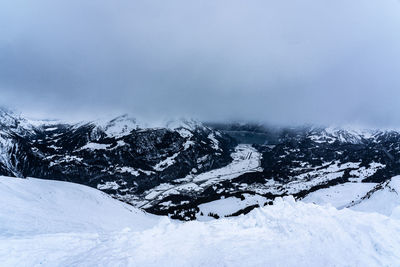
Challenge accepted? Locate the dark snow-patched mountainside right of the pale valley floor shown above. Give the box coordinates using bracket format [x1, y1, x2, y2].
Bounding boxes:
[184, 125, 400, 220]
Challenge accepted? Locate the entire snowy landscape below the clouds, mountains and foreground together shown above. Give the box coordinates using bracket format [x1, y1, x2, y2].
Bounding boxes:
[0, 111, 400, 266]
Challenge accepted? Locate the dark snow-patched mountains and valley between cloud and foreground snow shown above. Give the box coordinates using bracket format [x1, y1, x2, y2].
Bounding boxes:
[0, 109, 400, 220]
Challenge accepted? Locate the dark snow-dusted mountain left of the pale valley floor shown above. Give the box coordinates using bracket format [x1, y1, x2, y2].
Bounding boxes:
[0, 110, 236, 220]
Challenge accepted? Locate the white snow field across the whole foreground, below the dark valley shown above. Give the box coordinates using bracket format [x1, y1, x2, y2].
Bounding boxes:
[0, 177, 400, 266]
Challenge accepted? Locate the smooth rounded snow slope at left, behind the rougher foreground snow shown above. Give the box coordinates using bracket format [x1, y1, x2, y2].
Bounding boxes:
[0, 176, 157, 239]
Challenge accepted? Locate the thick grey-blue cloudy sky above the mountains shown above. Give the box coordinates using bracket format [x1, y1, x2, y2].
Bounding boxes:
[0, 0, 400, 127]
